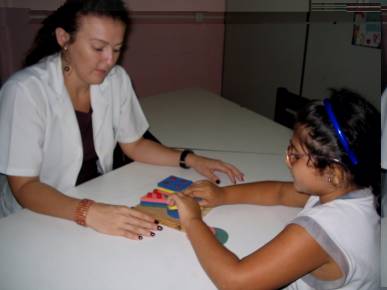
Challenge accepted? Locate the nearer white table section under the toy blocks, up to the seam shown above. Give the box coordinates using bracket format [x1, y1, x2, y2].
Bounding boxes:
[0, 152, 299, 290]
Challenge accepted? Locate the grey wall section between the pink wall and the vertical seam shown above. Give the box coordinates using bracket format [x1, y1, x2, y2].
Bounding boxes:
[222, 13, 306, 118]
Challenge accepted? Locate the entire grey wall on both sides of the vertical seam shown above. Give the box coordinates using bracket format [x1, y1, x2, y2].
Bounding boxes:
[222, 12, 381, 118]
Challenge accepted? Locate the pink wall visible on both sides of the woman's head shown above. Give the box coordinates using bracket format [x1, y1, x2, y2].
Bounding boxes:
[0, 7, 224, 97]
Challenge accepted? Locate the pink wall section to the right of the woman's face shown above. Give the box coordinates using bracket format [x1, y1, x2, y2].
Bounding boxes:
[123, 15, 224, 96]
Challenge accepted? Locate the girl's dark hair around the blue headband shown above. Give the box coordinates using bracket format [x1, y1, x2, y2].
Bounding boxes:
[295, 89, 381, 212]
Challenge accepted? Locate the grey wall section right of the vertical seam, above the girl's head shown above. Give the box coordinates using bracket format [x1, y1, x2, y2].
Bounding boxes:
[304, 13, 382, 108]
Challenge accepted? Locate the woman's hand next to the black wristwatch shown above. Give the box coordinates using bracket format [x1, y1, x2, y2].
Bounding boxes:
[187, 153, 244, 184]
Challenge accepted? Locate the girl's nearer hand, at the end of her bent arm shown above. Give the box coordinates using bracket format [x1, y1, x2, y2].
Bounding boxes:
[170, 192, 202, 229]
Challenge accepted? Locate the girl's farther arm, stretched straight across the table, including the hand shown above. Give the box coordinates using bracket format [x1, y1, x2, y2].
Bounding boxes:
[184, 181, 309, 207]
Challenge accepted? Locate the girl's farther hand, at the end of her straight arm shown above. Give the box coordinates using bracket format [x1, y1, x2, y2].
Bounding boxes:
[183, 180, 225, 207]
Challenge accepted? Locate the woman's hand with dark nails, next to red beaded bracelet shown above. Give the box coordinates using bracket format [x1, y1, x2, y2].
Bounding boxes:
[86, 203, 162, 240]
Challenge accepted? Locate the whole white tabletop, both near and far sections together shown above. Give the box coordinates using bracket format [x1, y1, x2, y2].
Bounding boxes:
[0, 90, 299, 290]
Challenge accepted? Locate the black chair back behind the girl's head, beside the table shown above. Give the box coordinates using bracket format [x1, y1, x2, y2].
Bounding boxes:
[274, 87, 310, 129]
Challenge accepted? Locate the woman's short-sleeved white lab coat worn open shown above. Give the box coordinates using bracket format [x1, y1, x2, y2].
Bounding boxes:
[0, 54, 148, 216]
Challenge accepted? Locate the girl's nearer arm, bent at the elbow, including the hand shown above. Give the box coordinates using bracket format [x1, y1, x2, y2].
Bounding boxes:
[173, 194, 330, 290]
